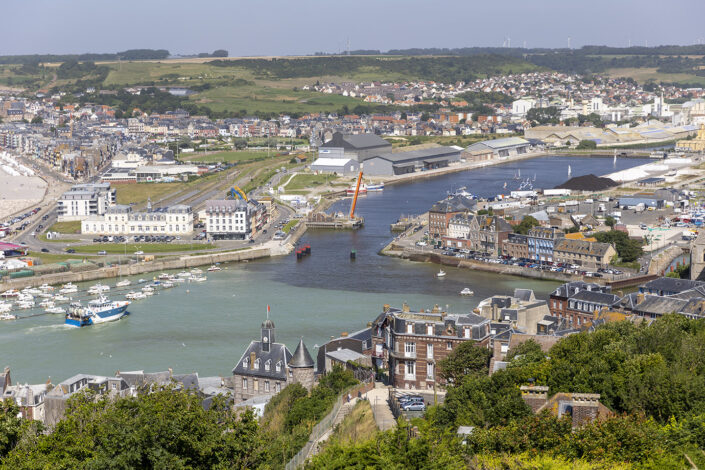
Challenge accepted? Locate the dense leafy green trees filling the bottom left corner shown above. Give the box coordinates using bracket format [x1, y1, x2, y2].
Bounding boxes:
[2, 388, 264, 469]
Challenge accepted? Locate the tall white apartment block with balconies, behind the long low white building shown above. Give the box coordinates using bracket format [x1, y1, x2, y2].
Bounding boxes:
[57, 183, 116, 222]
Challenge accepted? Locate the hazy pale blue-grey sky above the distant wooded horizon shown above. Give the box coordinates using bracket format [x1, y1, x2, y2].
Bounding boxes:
[0, 0, 705, 56]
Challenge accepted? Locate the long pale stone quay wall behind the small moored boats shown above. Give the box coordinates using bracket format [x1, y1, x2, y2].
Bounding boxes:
[0, 248, 271, 290]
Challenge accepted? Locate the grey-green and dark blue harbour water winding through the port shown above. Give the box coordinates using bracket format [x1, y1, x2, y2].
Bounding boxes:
[0, 157, 648, 383]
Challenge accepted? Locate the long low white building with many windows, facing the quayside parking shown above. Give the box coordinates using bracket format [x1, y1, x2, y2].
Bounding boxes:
[81, 205, 193, 236]
